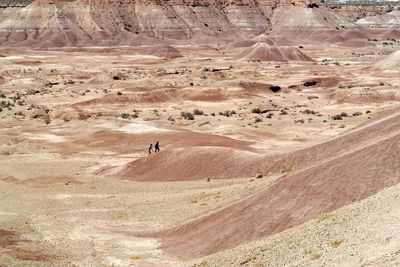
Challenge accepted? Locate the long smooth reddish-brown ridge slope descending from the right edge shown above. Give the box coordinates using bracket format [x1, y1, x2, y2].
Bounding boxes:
[150, 111, 400, 258]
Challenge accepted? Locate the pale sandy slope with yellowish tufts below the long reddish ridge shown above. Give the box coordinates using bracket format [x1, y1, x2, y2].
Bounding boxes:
[193, 180, 400, 266]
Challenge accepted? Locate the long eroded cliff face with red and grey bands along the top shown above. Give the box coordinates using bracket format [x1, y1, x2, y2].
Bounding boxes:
[0, 0, 394, 47]
